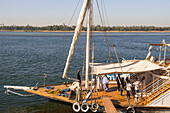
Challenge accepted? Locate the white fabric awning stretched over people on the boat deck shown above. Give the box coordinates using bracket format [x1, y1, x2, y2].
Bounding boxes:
[91, 60, 163, 75]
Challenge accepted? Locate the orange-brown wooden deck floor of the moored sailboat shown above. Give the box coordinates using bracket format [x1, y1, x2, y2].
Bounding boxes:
[24, 84, 144, 107]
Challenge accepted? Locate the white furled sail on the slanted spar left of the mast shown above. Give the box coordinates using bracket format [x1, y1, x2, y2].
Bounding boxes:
[63, 0, 89, 78]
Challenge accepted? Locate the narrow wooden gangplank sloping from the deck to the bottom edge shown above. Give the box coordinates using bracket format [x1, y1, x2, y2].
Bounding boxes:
[102, 96, 117, 113]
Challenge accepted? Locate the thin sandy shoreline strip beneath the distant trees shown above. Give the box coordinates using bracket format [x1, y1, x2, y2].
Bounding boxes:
[0, 30, 170, 33]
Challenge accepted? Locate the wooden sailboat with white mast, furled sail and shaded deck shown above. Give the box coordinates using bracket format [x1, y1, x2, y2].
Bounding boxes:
[4, 0, 170, 112]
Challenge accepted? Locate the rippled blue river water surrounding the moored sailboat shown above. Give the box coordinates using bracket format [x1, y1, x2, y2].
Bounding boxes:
[0, 32, 170, 113]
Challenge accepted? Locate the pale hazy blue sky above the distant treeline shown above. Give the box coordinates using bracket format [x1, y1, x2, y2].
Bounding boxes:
[0, 0, 170, 27]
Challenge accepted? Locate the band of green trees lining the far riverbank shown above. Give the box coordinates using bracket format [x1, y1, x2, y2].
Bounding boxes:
[0, 24, 170, 31]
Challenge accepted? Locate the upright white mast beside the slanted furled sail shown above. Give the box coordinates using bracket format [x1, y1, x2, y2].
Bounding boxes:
[85, 0, 92, 90]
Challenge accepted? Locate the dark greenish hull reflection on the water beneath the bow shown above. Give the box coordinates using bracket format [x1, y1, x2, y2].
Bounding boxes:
[8, 100, 92, 113]
